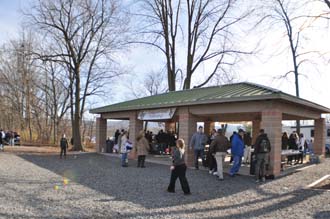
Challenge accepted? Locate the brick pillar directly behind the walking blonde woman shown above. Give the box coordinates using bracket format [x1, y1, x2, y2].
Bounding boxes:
[179, 108, 197, 166]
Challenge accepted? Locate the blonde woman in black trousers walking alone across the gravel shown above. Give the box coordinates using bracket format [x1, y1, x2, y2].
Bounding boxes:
[167, 139, 191, 195]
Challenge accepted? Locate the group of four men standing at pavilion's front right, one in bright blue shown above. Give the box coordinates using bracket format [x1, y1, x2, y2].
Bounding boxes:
[189, 126, 271, 182]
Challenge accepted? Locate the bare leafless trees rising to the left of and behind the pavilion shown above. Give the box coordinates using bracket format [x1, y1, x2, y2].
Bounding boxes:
[0, 0, 330, 150]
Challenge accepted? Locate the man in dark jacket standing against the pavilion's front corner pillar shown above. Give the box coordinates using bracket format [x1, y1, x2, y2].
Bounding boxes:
[254, 129, 271, 182]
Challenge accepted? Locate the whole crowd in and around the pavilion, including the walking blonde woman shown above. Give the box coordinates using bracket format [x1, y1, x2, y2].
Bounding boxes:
[87, 126, 312, 194]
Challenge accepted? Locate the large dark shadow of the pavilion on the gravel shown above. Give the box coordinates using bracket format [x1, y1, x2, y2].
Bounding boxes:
[19, 154, 255, 208]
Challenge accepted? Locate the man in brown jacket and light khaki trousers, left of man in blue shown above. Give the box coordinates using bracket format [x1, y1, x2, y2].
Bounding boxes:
[210, 129, 230, 180]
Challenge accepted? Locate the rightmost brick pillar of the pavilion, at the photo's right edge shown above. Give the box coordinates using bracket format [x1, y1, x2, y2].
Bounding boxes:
[313, 118, 326, 155]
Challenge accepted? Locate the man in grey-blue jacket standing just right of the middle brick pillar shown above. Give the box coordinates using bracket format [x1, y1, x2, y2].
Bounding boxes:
[190, 126, 207, 170]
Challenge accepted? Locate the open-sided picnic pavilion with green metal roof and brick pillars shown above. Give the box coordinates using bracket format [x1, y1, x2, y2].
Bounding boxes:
[90, 83, 330, 176]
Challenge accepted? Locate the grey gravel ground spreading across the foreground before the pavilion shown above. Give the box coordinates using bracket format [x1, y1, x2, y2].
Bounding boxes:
[0, 152, 330, 219]
